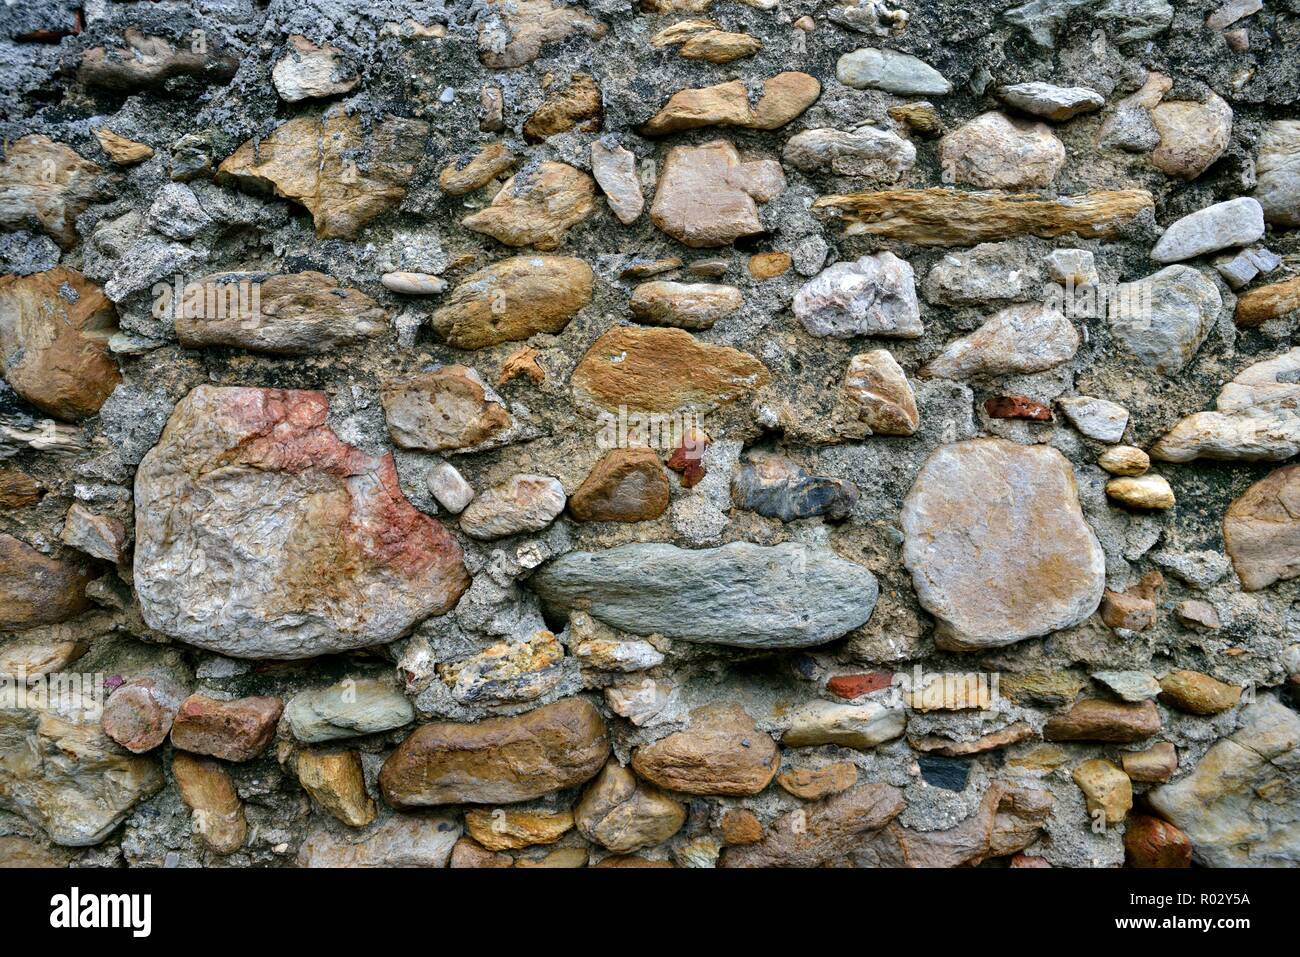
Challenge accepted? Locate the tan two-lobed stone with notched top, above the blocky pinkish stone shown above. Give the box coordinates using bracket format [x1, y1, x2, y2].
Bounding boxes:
[640, 73, 822, 137]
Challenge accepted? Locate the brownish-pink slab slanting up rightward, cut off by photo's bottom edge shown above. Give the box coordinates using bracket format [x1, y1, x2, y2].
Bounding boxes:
[719, 783, 906, 867]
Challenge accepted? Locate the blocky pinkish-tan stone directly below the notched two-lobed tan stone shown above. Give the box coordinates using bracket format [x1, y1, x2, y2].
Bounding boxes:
[650, 140, 785, 248]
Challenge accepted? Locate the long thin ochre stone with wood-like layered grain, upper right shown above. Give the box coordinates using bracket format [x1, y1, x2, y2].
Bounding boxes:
[813, 189, 1154, 246]
